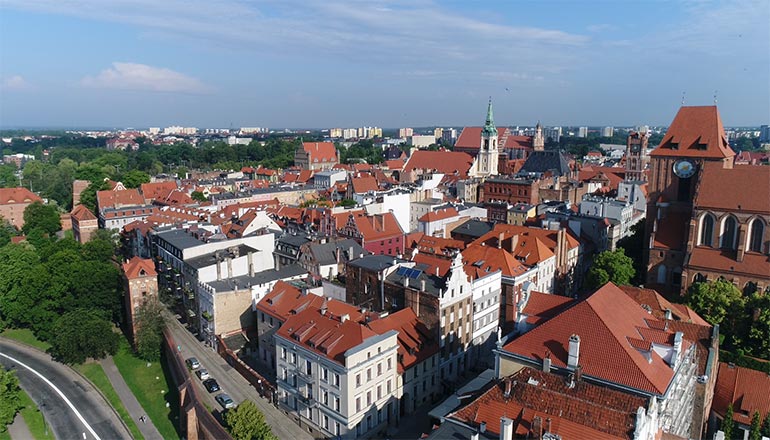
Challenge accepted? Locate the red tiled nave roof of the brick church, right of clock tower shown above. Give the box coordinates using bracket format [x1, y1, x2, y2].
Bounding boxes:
[694, 162, 770, 215]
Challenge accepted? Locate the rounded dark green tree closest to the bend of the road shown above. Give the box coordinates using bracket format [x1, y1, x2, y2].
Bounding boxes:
[50, 309, 119, 364]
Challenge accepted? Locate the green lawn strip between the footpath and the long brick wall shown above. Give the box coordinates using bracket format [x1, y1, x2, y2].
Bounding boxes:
[112, 339, 179, 438]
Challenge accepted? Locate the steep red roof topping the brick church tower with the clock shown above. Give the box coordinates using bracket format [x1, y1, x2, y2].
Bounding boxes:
[650, 105, 735, 159]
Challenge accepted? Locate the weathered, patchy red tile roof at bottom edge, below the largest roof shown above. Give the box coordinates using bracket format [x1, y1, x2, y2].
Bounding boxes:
[448, 367, 648, 439]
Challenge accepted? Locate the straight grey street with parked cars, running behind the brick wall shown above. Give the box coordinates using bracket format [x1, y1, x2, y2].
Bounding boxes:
[166, 314, 313, 440]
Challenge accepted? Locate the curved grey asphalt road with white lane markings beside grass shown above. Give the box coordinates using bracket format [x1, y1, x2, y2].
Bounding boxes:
[0, 338, 131, 440]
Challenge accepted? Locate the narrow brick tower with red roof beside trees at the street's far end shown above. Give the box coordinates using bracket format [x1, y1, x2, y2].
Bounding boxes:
[122, 257, 158, 344]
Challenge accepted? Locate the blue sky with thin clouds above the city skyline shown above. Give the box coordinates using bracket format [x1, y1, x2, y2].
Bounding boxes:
[0, 0, 770, 128]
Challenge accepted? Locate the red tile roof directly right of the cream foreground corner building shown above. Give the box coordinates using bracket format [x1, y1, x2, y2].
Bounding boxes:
[369, 307, 439, 373]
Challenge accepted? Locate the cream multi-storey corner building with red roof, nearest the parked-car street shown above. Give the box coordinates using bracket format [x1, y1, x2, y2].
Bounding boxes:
[275, 306, 400, 439]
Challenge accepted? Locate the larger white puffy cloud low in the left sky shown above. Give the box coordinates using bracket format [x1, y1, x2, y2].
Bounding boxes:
[81, 61, 209, 93]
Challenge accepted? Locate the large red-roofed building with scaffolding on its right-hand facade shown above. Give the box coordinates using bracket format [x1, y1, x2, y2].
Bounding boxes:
[496, 283, 698, 438]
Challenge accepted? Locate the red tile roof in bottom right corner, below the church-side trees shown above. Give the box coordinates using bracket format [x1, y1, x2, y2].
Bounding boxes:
[712, 362, 770, 425]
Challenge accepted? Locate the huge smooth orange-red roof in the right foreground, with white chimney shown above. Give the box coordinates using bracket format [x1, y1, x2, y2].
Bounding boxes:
[504, 283, 691, 395]
